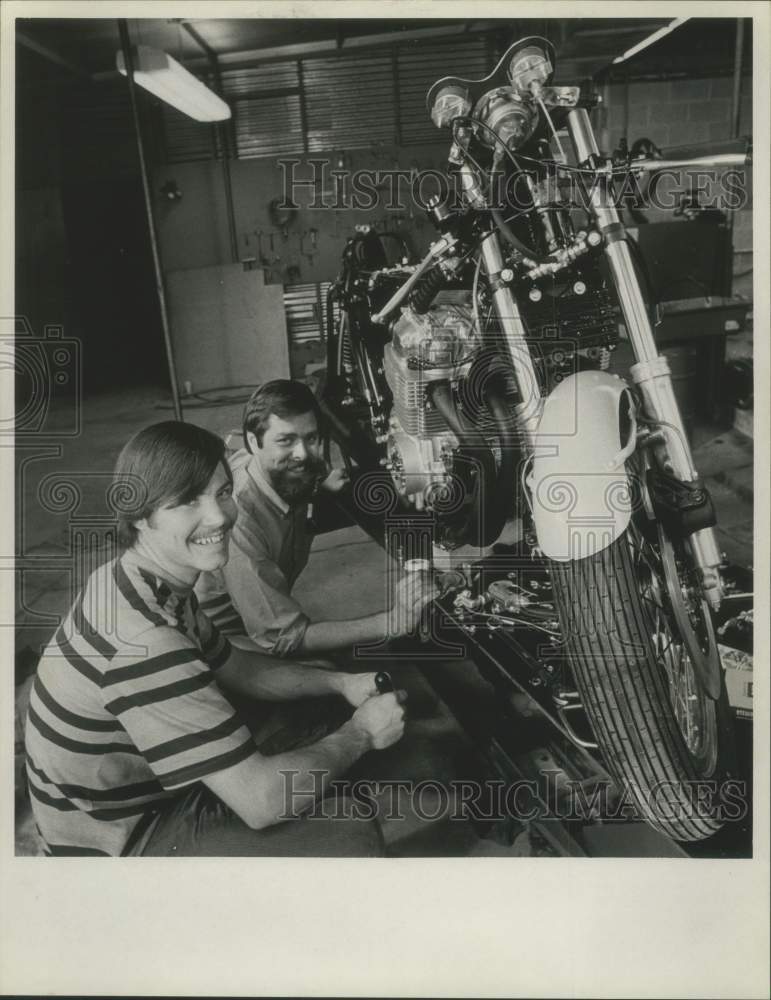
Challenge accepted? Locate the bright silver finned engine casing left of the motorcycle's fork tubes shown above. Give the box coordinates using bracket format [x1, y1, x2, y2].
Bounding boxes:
[384, 291, 480, 509]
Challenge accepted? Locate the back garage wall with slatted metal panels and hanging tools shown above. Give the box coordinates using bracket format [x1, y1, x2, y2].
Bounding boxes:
[153, 32, 510, 375]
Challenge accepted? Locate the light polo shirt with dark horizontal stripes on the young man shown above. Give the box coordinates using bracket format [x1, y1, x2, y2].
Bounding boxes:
[26, 551, 255, 855]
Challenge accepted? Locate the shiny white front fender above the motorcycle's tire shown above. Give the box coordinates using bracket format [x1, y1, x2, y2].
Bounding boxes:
[527, 371, 637, 562]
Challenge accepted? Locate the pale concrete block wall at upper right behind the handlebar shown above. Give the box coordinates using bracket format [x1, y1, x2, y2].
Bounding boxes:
[597, 76, 752, 298]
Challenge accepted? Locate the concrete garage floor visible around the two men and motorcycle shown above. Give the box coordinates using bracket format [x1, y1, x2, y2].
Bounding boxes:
[15, 335, 753, 855]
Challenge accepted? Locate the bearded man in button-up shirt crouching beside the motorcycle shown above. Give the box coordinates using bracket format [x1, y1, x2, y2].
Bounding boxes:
[196, 379, 435, 657]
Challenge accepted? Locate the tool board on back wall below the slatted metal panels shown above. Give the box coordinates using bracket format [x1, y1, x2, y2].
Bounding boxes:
[153, 141, 456, 285]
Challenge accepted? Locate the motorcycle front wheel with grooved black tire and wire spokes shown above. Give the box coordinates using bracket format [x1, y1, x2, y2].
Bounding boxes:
[551, 521, 733, 841]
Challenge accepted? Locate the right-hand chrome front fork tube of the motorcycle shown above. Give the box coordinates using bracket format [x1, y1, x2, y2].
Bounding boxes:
[567, 108, 722, 609]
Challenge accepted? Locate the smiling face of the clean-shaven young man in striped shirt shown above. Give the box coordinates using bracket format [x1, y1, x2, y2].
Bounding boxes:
[135, 465, 236, 583]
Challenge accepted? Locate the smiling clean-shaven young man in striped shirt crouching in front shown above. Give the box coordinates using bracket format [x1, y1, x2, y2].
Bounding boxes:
[26, 421, 404, 856]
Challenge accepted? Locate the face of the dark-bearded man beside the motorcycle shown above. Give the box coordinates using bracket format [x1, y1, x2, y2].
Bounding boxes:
[247, 413, 327, 503]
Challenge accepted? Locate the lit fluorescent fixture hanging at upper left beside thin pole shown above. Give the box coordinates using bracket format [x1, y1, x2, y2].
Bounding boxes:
[115, 45, 230, 122]
